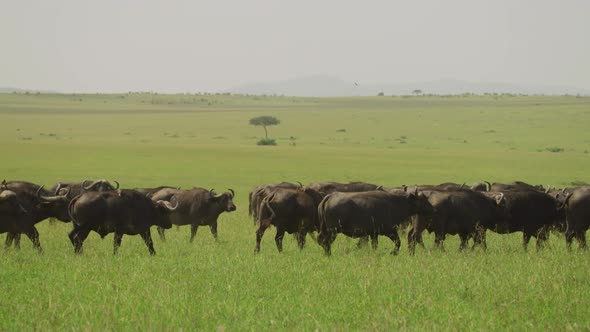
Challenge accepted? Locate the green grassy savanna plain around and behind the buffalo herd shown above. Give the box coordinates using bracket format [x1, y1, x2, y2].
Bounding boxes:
[0, 94, 590, 330]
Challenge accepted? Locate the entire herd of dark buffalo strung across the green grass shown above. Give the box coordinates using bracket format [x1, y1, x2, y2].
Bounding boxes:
[0, 180, 590, 255]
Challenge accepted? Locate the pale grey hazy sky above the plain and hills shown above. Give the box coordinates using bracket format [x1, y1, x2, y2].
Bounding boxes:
[0, 0, 590, 92]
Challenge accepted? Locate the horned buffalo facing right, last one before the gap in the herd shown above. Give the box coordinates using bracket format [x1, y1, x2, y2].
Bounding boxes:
[152, 188, 236, 243]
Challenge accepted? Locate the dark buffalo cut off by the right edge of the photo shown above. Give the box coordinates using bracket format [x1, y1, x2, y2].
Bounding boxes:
[565, 186, 590, 249]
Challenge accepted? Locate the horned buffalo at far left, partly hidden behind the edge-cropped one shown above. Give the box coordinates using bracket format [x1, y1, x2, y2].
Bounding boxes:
[2, 181, 70, 250]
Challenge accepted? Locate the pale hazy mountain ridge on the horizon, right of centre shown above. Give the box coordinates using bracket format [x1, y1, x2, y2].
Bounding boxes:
[225, 76, 590, 97]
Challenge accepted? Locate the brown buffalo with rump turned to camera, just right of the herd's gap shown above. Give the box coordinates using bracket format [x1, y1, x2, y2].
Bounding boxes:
[254, 188, 323, 252]
